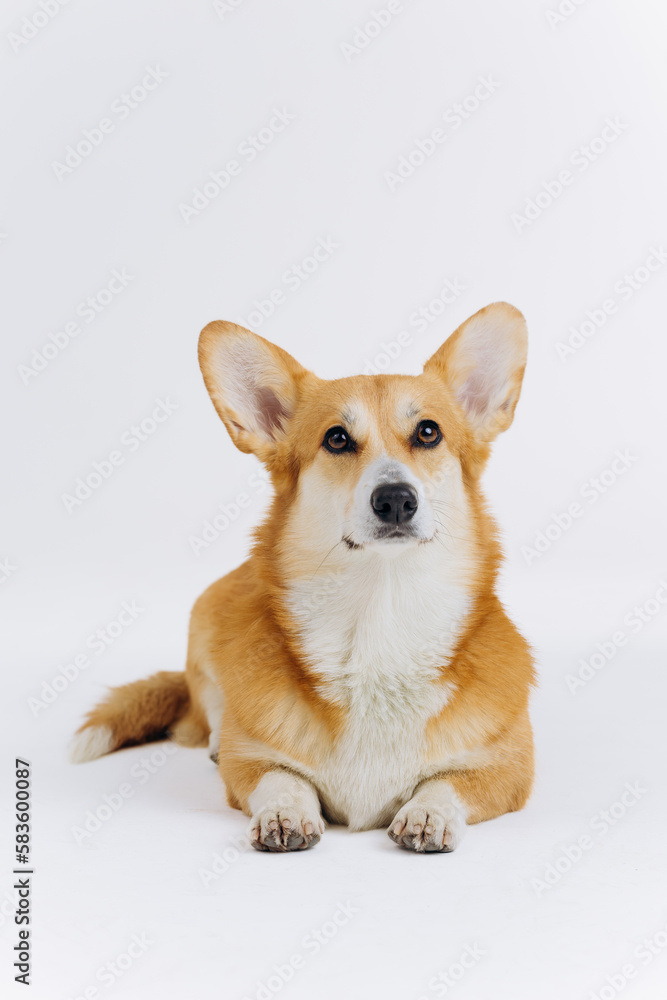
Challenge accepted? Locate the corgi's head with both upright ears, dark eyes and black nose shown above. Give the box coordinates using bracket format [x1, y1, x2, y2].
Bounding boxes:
[199, 303, 527, 558]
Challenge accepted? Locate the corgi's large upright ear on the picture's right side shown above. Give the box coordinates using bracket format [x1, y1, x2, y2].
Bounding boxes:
[424, 302, 528, 443]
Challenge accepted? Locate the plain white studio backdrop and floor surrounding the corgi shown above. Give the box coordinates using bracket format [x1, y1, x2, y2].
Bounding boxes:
[0, 0, 667, 1000]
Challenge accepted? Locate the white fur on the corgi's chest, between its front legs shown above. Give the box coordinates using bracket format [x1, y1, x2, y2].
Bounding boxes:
[290, 544, 470, 830]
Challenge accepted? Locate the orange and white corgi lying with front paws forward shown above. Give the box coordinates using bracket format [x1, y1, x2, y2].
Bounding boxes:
[72, 303, 534, 853]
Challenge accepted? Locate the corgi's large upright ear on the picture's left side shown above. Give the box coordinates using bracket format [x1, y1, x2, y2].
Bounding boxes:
[199, 320, 308, 462]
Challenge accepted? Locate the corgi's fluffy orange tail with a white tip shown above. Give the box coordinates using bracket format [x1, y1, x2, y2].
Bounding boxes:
[70, 670, 190, 764]
